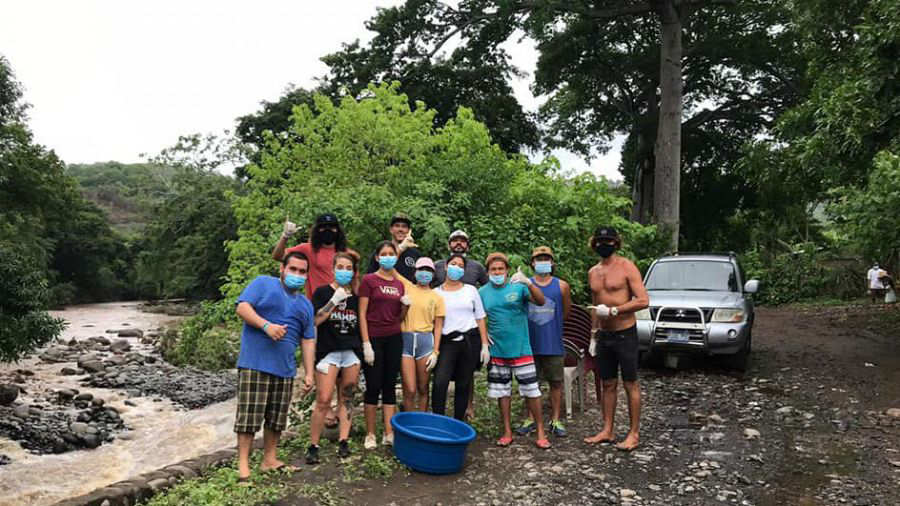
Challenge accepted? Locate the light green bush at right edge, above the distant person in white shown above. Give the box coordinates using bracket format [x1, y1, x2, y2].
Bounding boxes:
[829, 152, 900, 274]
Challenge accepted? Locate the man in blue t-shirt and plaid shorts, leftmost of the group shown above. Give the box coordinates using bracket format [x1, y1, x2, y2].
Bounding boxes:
[234, 253, 316, 483]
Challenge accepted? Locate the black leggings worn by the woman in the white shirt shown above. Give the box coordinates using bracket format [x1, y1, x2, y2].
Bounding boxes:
[431, 335, 475, 421]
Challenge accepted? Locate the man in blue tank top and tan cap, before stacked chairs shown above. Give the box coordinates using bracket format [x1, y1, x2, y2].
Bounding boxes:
[516, 246, 572, 437]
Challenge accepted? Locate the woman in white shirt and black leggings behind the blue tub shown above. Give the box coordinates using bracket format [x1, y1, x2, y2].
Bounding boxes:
[430, 253, 490, 421]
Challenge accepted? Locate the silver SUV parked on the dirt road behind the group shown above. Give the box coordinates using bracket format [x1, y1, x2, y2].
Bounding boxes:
[635, 253, 759, 371]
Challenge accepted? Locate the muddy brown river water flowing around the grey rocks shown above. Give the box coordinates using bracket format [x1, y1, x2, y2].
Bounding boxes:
[0, 302, 235, 506]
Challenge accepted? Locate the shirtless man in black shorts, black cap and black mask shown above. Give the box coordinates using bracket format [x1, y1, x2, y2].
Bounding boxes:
[584, 226, 649, 451]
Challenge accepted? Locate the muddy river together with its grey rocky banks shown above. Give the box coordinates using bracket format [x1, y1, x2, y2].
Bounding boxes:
[0, 302, 235, 506]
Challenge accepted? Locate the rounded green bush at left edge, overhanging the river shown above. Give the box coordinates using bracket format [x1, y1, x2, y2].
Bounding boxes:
[0, 241, 64, 362]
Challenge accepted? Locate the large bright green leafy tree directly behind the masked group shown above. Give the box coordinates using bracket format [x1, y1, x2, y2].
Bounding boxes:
[223, 84, 654, 300]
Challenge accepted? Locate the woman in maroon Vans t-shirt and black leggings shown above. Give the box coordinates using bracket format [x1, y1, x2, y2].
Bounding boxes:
[359, 241, 410, 450]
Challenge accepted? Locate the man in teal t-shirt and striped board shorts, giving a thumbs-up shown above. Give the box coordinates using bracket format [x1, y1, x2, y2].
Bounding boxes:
[478, 253, 550, 449]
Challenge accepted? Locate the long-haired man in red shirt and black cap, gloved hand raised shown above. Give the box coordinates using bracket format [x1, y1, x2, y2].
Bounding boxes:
[272, 213, 359, 298]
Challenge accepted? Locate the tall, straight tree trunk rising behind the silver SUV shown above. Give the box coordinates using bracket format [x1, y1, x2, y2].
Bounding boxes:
[653, 0, 683, 251]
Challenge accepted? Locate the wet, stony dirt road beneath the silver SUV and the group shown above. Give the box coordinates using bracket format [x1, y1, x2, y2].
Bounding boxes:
[278, 305, 900, 505]
